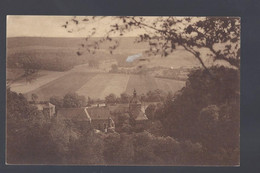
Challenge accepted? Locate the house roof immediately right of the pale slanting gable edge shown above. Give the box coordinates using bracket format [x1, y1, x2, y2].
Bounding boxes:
[87, 107, 111, 120]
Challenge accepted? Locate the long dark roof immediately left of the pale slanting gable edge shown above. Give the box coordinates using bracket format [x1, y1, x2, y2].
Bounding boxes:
[57, 108, 91, 121]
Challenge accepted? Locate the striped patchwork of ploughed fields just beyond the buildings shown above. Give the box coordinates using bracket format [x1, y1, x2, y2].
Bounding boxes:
[15, 71, 185, 100]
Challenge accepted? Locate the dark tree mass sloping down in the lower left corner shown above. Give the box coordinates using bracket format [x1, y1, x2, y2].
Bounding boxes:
[7, 90, 59, 164]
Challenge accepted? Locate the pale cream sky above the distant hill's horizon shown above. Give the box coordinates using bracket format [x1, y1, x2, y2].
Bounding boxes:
[7, 15, 158, 37]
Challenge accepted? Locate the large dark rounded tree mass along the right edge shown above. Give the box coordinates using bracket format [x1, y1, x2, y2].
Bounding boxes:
[156, 67, 240, 164]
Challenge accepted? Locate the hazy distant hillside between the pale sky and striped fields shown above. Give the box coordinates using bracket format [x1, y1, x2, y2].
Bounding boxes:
[7, 37, 198, 71]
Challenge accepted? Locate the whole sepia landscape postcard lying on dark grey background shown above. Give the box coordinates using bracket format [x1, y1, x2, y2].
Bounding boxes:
[5, 15, 240, 166]
